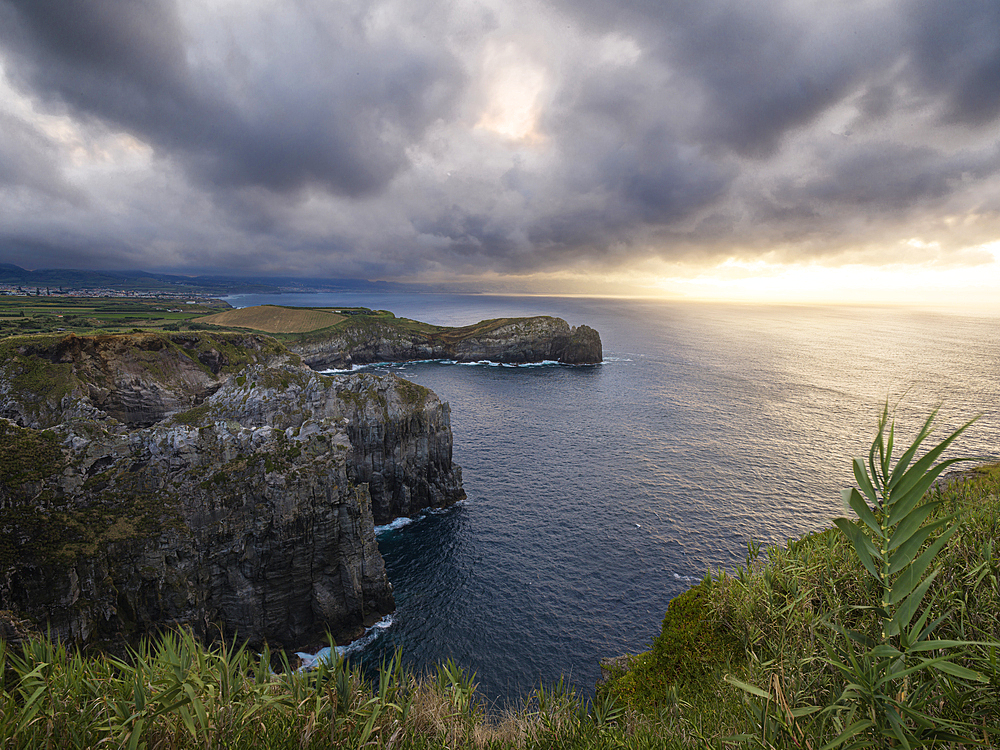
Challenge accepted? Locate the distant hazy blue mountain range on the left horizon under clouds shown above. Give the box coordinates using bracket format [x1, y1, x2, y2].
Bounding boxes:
[0, 263, 450, 295]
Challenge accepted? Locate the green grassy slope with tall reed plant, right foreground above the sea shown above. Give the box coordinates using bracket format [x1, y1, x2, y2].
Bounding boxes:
[604, 414, 1000, 748]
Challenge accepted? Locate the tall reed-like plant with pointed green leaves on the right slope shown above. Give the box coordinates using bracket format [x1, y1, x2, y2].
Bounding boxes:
[826, 405, 985, 747]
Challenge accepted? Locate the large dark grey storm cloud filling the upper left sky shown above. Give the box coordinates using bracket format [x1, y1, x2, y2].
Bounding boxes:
[4, 0, 460, 195]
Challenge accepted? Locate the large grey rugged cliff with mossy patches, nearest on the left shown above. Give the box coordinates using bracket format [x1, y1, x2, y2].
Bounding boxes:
[0, 333, 464, 645]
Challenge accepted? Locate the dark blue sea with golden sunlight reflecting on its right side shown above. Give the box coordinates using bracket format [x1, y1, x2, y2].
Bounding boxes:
[229, 294, 1000, 705]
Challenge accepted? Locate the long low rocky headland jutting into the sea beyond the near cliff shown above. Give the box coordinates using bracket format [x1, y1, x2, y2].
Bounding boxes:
[288, 316, 603, 370]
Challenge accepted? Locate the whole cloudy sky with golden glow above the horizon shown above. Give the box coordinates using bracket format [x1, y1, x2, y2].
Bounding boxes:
[0, 0, 1000, 305]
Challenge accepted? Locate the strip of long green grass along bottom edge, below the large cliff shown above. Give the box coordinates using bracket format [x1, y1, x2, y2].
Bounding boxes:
[0, 631, 677, 750]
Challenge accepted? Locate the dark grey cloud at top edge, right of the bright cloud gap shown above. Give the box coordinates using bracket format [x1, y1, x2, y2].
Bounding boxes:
[544, 0, 899, 158]
